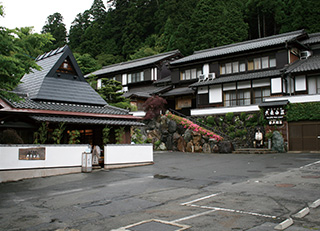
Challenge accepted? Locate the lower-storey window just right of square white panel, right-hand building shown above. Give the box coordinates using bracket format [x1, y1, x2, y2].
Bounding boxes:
[224, 89, 251, 107]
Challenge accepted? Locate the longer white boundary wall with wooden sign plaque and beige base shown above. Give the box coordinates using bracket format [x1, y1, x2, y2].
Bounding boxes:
[0, 144, 88, 182]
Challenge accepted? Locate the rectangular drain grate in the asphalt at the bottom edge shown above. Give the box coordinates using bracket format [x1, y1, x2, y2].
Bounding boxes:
[126, 220, 189, 231]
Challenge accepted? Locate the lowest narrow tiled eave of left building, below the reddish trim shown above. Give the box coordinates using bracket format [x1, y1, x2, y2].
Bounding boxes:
[30, 115, 145, 126]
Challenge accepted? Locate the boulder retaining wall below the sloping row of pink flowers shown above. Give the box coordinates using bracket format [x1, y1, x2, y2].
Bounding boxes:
[139, 116, 234, 153]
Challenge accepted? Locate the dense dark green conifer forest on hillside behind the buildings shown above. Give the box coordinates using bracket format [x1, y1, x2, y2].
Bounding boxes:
[12, 0, 320, 73]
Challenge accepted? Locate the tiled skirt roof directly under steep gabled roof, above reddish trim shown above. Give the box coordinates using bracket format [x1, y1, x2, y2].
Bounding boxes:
[8, 98, 128, 115]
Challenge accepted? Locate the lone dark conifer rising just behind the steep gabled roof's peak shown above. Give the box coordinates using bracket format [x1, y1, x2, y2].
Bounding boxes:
[41, 12, 67, 50]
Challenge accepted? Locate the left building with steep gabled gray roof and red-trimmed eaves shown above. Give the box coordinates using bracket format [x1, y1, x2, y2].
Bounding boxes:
[0, 46, 143, 146]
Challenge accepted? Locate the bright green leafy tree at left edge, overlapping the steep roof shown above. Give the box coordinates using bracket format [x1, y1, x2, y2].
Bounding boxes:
[0, 5, 52, 100]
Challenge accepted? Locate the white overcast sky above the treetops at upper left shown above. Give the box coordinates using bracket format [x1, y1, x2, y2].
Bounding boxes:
[0, 0, 100, 33]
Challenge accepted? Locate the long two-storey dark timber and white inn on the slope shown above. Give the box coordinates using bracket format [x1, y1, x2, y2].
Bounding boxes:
[93, 30, 320, 151]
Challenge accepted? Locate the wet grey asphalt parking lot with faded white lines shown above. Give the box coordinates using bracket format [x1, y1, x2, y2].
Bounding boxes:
[0, 152, 320, 231]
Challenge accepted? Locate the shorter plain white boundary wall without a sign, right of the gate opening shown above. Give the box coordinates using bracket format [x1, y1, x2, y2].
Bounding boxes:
[104, 144, 153, 168]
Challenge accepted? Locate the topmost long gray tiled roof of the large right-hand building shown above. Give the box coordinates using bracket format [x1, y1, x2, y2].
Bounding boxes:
[170, 30, 305, 65]
